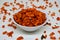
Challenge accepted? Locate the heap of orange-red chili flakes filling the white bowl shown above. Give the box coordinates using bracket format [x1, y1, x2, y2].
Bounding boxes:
[13, 8, 46, 27]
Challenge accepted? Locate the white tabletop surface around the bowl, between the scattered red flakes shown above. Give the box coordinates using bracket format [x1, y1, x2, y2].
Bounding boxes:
[0, 0, 60, 40]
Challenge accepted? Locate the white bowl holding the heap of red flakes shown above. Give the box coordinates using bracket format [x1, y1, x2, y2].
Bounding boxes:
[12, 12, 47, 31]
